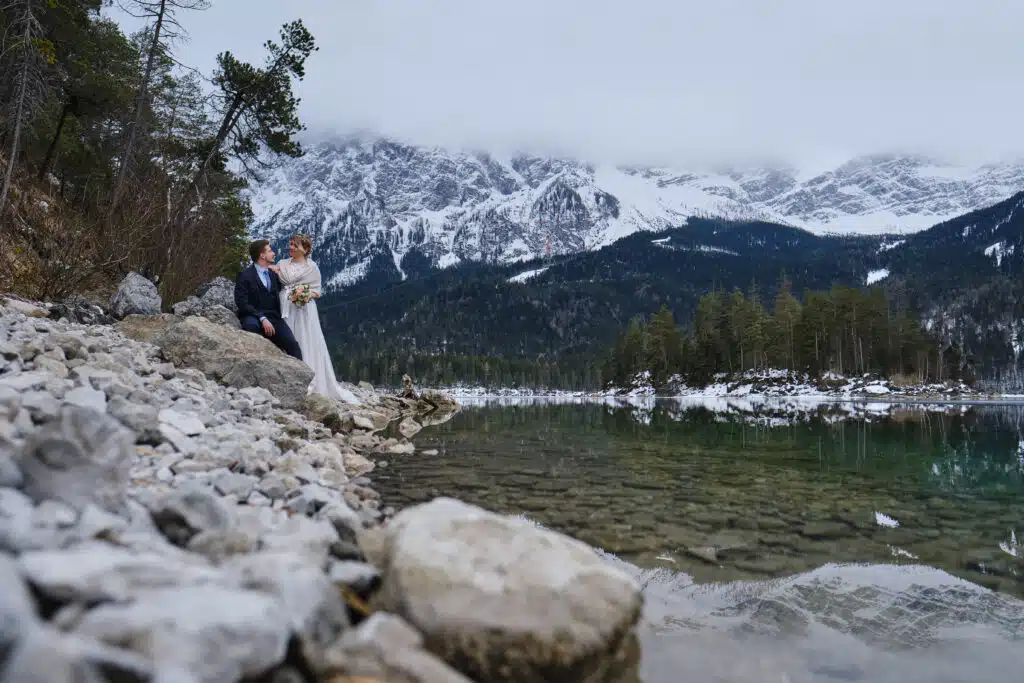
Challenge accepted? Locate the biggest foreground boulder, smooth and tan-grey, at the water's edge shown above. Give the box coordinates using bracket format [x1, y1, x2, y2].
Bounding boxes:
[360, 498, 643, 683]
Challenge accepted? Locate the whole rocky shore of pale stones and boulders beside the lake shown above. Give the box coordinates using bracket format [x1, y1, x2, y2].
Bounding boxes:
[0, 279, 642, 683]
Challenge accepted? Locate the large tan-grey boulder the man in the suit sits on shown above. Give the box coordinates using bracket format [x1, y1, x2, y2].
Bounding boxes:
[151, 317, 313, 409]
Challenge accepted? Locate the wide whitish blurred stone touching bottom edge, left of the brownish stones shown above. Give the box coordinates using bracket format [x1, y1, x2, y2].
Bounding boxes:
[76, 586, 291, 683]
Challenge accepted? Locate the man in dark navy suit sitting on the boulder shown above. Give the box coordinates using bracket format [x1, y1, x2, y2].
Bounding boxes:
[234, 240, 302, 360]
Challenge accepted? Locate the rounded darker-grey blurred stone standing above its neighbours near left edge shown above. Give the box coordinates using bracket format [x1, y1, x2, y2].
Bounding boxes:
[18, 405, 135, 510]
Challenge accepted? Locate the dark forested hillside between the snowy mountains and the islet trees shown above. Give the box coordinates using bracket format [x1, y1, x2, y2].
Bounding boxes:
[322, 196, 1024, 384]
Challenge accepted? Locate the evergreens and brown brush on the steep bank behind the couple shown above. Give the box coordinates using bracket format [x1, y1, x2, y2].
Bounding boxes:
[0, 0, 316, 302]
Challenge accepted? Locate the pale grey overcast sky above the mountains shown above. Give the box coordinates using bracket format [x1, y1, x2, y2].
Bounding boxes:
[108, 0, 1024, 164]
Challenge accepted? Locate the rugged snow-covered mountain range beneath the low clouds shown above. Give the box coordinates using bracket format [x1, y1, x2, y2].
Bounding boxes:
[250, 137, 1024, 289]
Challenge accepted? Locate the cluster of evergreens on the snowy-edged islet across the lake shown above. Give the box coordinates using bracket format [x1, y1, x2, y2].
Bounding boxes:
[602, 284, 964, 387]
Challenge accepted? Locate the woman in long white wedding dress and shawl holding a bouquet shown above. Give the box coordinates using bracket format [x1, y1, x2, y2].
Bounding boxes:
[270, 234, 359, 403]
